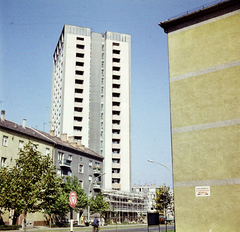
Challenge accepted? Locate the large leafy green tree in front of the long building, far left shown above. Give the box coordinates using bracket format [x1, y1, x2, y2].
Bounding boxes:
[0, 142, 62, 231]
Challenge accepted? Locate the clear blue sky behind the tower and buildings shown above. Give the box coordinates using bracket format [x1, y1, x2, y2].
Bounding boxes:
[0, 0, 216, 187]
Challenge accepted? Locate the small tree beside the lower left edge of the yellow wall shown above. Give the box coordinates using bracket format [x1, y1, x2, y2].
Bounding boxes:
[155, 184, 171, 213]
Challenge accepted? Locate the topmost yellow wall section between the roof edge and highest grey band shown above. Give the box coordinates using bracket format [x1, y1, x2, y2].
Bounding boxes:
[168, 14, 240, 77]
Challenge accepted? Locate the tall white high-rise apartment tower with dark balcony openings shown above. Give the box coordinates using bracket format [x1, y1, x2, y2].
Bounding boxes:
[50, 25, 131, 192]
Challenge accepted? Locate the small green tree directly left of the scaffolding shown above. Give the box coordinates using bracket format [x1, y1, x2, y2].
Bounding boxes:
[90, 192, 110, 218]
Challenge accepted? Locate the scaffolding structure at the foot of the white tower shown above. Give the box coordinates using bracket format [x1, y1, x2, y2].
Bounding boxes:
[102, 190, 148, 223]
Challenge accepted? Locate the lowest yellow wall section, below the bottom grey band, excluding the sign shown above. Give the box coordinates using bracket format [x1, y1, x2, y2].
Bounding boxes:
[174, 185, 240, 232]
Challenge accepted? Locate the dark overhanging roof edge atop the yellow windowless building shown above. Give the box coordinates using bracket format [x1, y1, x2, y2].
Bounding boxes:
[158, 0, 240, 33]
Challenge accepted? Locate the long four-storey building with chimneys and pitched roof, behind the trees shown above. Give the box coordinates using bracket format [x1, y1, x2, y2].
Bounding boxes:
[0, 111, 103, 226]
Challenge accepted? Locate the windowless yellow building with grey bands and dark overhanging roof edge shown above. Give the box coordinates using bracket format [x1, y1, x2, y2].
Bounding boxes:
[160, 0, 240, 232]
